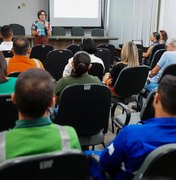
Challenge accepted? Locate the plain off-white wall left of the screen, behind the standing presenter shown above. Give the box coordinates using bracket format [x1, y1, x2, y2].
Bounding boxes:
[0, 0, 48, 35]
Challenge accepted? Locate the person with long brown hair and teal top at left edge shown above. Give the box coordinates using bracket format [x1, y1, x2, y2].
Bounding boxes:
[0, 51, 16, 94]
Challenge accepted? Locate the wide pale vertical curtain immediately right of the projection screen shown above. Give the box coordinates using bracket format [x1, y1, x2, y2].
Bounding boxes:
[108, 0, 158, 47]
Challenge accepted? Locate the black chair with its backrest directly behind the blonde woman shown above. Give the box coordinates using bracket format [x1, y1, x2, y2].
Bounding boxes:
[111, 66, 149, 132]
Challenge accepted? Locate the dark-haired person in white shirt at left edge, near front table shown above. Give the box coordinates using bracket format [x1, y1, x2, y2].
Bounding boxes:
[0, 25, 13, 51]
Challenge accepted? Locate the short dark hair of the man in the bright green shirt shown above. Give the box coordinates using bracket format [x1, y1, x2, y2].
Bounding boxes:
[15, 68, 54, 118]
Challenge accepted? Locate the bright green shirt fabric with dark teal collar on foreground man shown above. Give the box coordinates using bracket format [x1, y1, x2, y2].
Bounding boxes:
[6, 117, 81, 159]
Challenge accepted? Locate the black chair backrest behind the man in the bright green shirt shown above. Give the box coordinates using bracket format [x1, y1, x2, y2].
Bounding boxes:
[0, 150, 88, 180]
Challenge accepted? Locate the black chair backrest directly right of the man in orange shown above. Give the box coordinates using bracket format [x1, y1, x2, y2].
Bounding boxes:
[30, 44, 54, 67]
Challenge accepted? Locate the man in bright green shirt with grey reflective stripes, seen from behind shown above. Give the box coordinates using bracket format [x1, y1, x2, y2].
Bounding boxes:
[0, 68, 81, 161]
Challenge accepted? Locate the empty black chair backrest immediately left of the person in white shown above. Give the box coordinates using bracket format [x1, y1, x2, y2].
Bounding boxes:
[45, 49, 73, 81]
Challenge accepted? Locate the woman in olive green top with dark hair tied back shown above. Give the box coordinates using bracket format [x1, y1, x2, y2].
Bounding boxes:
[55, 51, 101, 104]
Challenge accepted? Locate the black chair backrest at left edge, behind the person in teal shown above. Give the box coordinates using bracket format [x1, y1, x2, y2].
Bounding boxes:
[0, 94, 18, 131]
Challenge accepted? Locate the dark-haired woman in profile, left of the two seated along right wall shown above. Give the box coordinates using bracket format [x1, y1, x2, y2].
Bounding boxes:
[142, 32, 160, 65]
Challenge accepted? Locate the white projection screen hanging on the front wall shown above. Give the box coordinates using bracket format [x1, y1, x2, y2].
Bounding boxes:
[49, 0, 102, 27]
